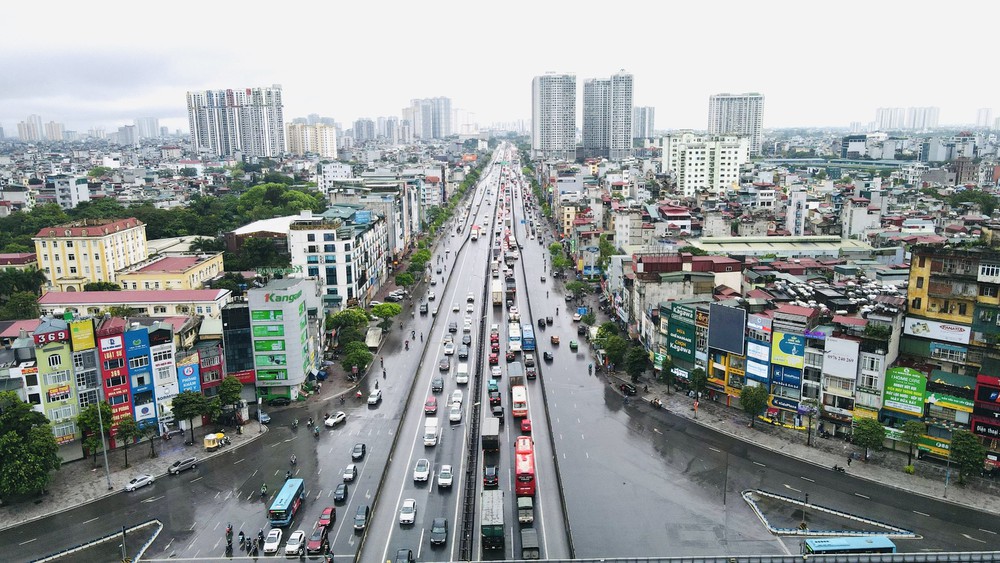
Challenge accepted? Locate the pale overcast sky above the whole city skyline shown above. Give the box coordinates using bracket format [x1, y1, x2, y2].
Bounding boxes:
[0, 0, 1000, 136]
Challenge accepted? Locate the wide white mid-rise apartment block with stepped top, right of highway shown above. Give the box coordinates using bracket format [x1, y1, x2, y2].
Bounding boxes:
[660, 131, 750, 197]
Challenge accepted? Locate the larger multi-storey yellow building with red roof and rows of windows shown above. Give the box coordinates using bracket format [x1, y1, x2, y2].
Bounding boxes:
[31, 217, 148, 291]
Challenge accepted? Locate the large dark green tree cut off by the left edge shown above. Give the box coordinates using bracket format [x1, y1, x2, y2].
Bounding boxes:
[0, 391, 61, 498]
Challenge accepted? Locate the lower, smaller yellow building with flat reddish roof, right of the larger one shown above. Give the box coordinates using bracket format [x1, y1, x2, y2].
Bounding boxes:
[118, 252, 223, 290]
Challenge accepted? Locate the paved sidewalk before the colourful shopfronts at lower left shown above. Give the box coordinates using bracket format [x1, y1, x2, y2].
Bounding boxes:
[0, 421, 267, 529]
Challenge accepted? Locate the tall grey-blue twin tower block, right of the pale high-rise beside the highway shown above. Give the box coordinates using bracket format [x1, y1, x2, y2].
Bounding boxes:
[583, 72, 633, 161]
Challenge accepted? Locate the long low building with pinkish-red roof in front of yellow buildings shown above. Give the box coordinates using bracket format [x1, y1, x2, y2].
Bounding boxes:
[38, 289, 231, 318]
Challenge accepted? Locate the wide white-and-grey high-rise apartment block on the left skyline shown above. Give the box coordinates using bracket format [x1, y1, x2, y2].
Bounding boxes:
[187, 84, 285, 158]
